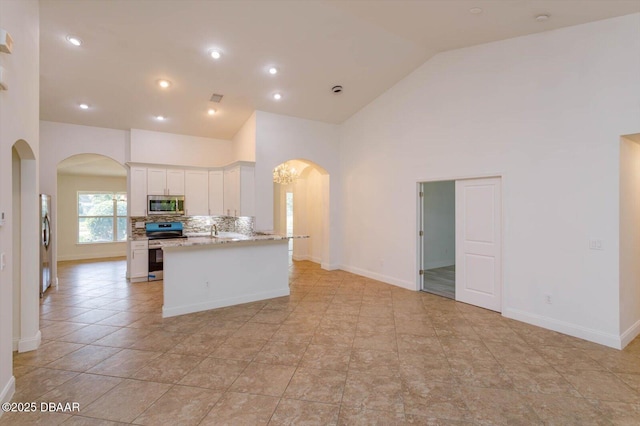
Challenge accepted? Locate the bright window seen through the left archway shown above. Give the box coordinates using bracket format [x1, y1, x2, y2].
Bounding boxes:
[78, 191, 127, 244]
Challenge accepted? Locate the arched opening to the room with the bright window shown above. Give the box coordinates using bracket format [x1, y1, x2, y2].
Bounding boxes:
[55, 153, 127, 261]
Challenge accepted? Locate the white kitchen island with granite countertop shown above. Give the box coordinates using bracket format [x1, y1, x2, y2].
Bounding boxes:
[157, 233, 305, 318]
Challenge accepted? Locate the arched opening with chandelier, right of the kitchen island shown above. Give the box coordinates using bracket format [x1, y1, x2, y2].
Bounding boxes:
[273, 159, 330, 268]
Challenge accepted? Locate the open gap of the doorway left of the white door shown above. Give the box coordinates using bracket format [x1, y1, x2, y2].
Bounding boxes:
[420, 180, 456, 299]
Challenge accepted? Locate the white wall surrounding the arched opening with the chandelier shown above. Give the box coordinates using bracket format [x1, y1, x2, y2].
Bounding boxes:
[255, 111, 340, 269]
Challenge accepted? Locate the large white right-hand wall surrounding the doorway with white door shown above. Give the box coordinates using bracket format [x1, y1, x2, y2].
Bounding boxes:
[340, 14, 640, 346]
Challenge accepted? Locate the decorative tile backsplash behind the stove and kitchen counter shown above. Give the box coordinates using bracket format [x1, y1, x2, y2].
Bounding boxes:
[129, 215, 254, 239]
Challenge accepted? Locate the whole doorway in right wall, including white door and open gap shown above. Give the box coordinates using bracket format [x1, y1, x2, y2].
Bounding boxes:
[418, 176, 503, 312]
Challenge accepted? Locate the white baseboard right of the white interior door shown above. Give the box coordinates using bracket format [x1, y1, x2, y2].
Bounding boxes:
[502, 308, 622, 349]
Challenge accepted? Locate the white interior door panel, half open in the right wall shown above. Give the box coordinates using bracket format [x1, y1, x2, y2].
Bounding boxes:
[456, 178, 502, 312]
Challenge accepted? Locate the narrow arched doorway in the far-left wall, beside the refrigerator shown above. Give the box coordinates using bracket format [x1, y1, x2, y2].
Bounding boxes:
[11, 140, 41, 352]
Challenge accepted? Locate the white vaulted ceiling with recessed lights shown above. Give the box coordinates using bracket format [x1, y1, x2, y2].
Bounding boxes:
[40, 0, 640, 139]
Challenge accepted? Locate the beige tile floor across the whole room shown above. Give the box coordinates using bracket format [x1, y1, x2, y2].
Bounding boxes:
[0, 260, 640, 425]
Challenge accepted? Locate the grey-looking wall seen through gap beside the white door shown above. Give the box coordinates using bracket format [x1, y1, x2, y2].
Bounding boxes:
[422, 181, 456, 269]
